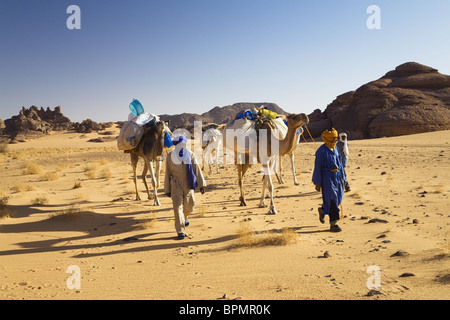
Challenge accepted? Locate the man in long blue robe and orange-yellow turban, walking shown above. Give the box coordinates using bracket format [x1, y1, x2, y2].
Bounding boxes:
[312, 128, 345, 232]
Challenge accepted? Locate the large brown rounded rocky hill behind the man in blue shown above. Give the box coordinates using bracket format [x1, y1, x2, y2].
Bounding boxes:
[308, 62, 450, 139]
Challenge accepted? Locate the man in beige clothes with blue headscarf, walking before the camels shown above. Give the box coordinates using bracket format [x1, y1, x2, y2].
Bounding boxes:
[164, 136, 206, 240]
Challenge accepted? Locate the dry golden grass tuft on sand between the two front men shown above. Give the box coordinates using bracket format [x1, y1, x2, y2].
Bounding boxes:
[237, 223, 297, 247]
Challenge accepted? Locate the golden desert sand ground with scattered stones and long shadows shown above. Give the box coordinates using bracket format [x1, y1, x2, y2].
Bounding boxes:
[0, 129, 450, 300]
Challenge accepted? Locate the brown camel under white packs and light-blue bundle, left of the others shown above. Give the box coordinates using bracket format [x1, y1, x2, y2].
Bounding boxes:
[126, 121, 171, 206]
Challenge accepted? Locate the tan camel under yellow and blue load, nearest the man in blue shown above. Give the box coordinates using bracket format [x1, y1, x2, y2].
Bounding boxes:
[223, 113, 309, 214]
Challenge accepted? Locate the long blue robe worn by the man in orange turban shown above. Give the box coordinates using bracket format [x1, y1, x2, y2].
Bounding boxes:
[312, 144, 345, 215]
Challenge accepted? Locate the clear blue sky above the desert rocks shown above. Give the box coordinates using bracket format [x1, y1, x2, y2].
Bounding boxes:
[0, 0, 450, 122]
